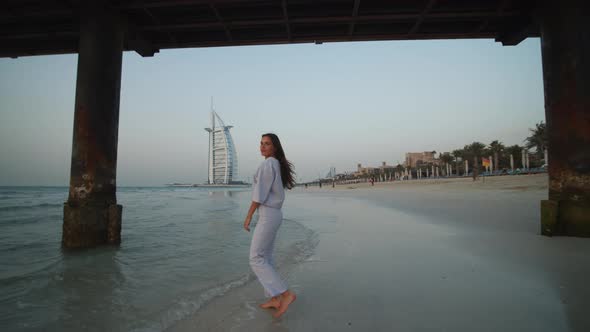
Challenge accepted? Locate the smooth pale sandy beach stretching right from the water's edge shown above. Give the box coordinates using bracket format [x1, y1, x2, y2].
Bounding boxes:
[170, 174, 590, 332]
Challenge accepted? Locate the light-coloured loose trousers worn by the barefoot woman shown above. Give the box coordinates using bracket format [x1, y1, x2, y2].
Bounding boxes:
[250, 205, 287, 297]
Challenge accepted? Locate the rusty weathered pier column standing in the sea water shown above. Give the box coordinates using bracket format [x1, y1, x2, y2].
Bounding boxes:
[62, 0, 124, 248]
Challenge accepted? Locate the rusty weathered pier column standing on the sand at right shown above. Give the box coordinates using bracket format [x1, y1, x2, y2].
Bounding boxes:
[538, 0, 590, 237]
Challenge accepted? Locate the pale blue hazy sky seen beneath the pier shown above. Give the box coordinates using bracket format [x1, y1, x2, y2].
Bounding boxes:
[0, 38, 545, 186]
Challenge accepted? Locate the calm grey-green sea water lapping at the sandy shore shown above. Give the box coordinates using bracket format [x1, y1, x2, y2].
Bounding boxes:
[0, 187, 317, 331]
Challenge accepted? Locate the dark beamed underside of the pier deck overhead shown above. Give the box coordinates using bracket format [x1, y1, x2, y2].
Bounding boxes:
[0, 0, 539, 57]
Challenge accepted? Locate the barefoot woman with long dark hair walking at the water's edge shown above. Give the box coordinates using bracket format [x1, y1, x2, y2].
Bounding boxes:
[244, 134, 296, 317]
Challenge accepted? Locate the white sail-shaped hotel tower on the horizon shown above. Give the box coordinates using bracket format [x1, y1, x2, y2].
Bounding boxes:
[205, 108, 238, 184]
